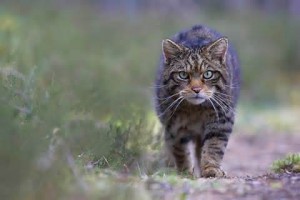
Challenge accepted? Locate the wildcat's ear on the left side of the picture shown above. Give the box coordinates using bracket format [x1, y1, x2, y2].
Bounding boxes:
[162, 39, 184, 62]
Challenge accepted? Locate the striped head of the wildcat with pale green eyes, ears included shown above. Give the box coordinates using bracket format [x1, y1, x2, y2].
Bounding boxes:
[162, 38, 228, 105]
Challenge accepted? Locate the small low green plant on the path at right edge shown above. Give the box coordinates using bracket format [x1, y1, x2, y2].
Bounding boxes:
[272, 153, 300, 173]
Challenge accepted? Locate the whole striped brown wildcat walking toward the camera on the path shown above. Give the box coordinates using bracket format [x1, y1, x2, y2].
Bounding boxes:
[155, 25, 240, 177]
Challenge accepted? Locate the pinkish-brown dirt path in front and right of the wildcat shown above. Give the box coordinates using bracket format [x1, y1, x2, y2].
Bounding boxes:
[146, 132, 300, 200]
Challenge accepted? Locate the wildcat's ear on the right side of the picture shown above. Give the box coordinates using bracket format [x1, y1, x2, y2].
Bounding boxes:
[205, 37, 228, 64]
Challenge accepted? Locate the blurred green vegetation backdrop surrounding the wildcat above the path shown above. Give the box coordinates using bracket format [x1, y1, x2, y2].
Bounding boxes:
[0, 0, 300, 199]
